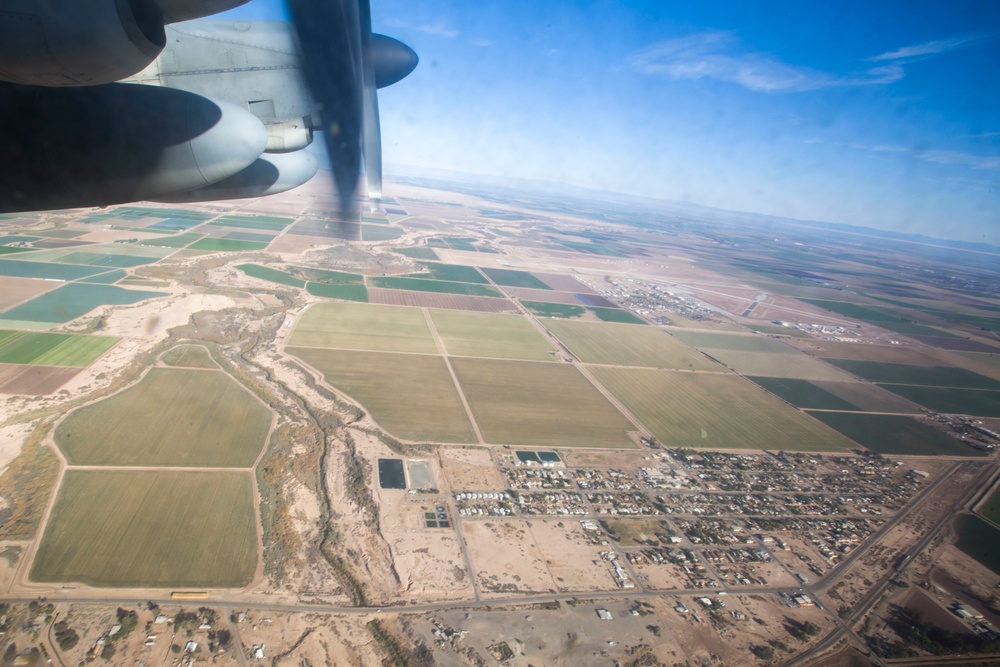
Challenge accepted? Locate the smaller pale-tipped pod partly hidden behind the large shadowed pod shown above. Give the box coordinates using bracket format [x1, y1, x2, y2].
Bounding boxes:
[156, 151, 319, 204]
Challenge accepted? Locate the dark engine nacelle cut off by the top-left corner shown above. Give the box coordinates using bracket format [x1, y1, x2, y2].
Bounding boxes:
[0, 0, 246, 86]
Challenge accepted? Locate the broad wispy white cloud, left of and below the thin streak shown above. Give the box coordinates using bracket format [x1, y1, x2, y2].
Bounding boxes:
[629, 31, 904, 93]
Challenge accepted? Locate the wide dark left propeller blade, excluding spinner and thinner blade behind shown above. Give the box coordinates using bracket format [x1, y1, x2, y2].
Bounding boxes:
[287, 0, 362, 219]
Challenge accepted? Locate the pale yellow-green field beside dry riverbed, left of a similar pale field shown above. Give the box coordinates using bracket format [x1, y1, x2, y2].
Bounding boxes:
[288, 303, 438, 354]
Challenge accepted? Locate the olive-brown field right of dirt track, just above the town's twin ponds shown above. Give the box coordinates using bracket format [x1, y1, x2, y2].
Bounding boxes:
[451, 358, 635, 448]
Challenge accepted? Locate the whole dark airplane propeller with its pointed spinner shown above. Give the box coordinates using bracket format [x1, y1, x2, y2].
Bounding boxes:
[287, 0, 418, 220]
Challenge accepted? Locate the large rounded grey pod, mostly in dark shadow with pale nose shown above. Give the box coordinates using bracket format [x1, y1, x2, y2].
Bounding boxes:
[0, 83, 267, 213]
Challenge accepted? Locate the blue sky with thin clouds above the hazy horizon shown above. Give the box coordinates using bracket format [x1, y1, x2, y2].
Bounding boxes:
[221, 0, 1000, 245]
